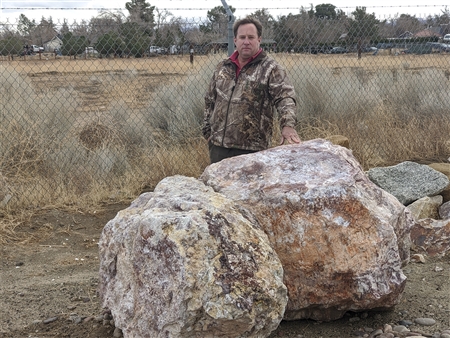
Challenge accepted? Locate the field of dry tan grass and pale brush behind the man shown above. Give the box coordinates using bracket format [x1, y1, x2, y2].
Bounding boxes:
[0, 54, 450, 242]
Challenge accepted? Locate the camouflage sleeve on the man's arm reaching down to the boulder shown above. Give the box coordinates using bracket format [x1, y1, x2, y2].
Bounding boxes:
[269, 65, 297, 129]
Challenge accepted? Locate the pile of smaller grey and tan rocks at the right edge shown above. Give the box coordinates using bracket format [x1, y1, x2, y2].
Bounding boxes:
[367, 161, 450, 256]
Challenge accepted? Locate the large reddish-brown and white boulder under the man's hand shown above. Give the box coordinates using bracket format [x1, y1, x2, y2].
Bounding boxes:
[200, 139, 413, 320]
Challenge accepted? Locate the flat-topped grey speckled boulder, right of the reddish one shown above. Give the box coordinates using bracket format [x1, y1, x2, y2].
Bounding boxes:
[367, 161, 449, 205]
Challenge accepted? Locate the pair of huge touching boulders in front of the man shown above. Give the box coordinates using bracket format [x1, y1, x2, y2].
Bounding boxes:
[99, 140, 426, 337]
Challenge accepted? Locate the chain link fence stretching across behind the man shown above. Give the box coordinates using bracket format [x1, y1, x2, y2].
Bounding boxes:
[0, 6, 450, 210]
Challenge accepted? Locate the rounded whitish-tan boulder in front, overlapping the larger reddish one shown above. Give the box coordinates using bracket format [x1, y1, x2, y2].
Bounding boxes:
[99, 176, 287, 338]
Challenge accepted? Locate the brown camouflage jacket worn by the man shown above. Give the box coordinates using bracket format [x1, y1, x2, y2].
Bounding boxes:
[202, 52, 297, 151]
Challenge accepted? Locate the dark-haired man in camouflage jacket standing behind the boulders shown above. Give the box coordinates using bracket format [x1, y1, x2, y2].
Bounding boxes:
[202, 17, 300, 163]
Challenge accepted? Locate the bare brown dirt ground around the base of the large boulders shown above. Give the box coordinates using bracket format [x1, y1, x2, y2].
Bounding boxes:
[0, 205, 450, 338]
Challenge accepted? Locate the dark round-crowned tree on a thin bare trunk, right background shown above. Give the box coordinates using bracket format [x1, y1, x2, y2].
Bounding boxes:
[347, 7, 380, 59]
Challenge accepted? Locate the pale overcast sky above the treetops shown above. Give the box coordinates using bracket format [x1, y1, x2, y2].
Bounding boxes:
[0, 0, 450, 24]
